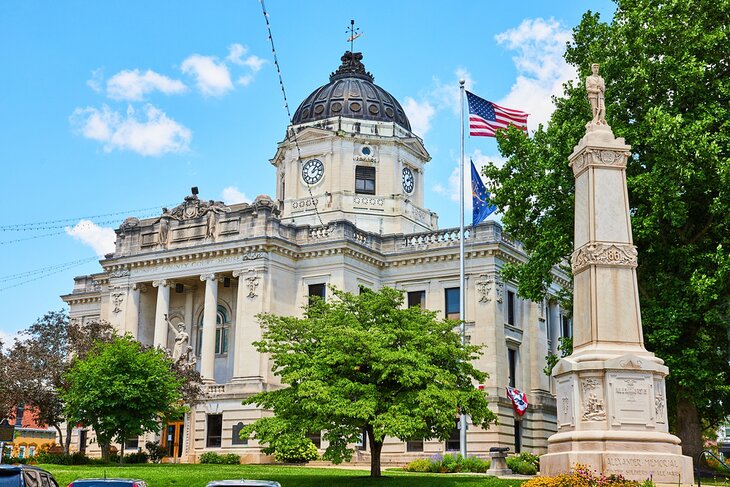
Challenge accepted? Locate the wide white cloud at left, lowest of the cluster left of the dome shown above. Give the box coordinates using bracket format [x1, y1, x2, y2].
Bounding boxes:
[70, 104, 192, 156]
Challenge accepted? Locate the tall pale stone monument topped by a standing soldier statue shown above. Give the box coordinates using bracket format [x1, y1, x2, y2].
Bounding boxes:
[540, 64, 693, 485]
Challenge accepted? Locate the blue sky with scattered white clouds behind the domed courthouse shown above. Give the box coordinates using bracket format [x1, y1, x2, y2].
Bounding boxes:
[0, 0, 614, 342]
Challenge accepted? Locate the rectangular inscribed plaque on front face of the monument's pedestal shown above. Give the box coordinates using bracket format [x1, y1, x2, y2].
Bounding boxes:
[608, 372, 655, 426]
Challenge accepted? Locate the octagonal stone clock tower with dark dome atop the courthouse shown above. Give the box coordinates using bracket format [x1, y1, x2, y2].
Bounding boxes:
[271, 51, 438, 234]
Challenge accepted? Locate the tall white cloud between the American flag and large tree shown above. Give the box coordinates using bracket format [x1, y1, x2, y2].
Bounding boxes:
[495, 18, 577, 130]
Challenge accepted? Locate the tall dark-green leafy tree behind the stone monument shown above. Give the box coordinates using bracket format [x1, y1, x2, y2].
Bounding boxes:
[485, 0, 730, 457]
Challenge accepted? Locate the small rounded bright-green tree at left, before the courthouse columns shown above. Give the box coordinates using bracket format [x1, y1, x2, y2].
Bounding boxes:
[62, 335, 185, 464]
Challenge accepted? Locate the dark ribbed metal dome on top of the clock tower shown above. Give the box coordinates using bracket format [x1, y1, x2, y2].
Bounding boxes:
[292, 51, 411, 132]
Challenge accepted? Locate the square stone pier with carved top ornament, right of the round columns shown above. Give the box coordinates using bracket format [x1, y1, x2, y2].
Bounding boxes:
[232, 268, 264, 384]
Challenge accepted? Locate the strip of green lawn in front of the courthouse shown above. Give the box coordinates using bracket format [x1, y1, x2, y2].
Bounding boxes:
[40, 464, 522, 487]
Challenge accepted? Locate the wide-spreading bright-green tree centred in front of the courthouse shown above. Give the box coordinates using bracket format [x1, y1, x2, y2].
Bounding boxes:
[242, 288, 496, 477]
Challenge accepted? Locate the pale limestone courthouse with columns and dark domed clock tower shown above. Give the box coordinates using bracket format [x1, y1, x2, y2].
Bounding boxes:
[63, 52, 570, 462]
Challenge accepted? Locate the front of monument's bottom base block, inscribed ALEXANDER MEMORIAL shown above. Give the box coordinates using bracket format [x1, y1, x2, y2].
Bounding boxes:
[604, 453, 686, 482]
